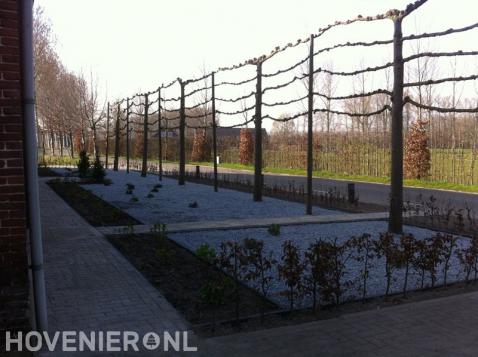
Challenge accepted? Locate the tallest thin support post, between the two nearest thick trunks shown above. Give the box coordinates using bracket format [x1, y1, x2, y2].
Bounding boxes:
[305, 35, 314, 214]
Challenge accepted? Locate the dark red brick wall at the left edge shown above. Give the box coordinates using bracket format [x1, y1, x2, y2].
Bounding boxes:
[0, 0, 29, 340]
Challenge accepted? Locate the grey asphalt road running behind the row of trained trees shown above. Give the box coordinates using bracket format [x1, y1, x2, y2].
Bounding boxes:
[164, 164, 478, 212]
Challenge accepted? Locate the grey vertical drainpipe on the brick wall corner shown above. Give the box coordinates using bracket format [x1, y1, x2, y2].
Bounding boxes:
[21, 0, 48, 331]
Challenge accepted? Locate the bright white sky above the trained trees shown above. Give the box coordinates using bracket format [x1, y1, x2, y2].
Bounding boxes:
[35, 0, 478, 126]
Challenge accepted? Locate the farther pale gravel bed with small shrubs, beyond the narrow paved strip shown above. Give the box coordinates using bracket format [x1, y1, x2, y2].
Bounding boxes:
[78, 171, 337, 224]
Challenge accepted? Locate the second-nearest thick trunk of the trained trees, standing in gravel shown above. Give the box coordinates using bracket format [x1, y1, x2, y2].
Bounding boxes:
[253, 61, 262, 201]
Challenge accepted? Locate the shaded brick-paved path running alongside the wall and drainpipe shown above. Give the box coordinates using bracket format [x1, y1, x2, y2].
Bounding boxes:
[36, 182, 195, 356]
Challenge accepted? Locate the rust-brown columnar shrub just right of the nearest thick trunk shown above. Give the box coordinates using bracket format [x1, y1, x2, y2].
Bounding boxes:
[404, 120, 431, 180]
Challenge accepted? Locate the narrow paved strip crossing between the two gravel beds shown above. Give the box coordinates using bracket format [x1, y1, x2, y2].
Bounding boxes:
[97, 212, 388, 235]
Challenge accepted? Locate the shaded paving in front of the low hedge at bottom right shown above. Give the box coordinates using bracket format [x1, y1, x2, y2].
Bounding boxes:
[203, 293, 478, 357]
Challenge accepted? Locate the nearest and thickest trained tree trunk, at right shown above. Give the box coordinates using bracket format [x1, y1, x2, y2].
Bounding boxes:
[388, 16, 404, 234]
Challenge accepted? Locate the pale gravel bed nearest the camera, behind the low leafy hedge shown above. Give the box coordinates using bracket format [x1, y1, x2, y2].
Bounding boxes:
[169, 221, 468, 308]
